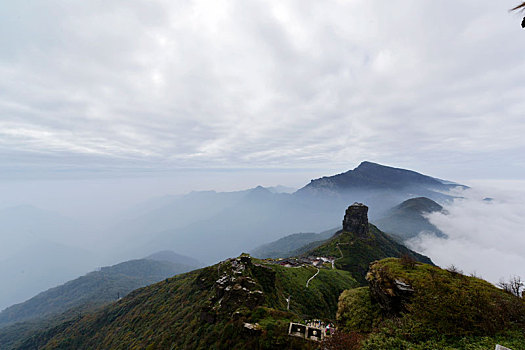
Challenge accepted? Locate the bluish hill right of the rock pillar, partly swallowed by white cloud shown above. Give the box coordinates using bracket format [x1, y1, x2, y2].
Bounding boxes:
[375, 197, 445, 240]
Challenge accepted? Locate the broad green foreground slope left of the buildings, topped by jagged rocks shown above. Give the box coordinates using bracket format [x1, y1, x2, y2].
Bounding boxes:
[17, 256, 357, 349]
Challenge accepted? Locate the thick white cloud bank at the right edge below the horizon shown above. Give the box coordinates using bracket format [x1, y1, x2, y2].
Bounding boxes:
[410, 181, 525, 283]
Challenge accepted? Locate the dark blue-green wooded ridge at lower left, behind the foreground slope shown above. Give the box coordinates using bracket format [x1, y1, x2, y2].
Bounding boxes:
[0, 259, 193, 349]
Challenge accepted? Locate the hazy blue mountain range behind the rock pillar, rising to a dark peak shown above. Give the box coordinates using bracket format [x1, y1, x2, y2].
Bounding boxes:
[116, 162, 462, 263]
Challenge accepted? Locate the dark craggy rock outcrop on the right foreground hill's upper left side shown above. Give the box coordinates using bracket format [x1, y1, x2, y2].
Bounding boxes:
[366, 263, 414, 315]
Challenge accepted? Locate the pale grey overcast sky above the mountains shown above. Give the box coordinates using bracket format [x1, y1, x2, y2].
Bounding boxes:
[0, 0, 525, 185]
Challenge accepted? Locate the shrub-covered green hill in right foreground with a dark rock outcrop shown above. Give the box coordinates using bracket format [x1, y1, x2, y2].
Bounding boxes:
[337, 258, 525, 350]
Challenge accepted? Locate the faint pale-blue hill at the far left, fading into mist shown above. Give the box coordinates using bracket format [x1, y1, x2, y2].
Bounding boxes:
[0, 205, 96, 310]
